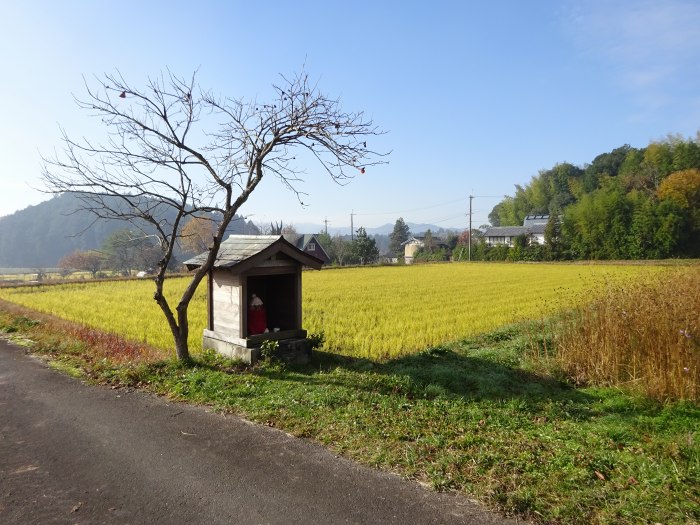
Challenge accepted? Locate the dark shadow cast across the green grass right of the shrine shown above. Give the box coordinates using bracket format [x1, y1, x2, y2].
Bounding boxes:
[252, 330, 592, 408]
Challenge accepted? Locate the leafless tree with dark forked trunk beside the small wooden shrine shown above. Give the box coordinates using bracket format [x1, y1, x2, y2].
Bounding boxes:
[43, 70, 385, 361]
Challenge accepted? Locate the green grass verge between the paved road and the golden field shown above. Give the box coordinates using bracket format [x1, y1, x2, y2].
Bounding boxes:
[0, 306, 700, 524]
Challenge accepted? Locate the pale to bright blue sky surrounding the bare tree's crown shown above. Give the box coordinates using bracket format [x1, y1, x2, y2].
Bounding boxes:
[0, 0, 700, 231]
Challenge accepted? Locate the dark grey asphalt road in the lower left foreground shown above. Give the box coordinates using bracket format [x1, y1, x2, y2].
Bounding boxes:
[0, 340, 515, 525]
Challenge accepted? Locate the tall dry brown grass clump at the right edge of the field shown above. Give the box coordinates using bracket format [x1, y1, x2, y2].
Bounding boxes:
[556, 266, 700, 401]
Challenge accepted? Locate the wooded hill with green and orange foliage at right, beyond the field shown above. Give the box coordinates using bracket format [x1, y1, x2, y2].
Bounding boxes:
[489, 134, 700, 259]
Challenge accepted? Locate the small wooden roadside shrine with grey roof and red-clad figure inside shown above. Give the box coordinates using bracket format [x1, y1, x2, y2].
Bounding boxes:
[185, 235, 323, 363]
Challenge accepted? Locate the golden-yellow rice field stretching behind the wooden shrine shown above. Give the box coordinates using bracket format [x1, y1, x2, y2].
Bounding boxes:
[0, 263, 663, 359]
